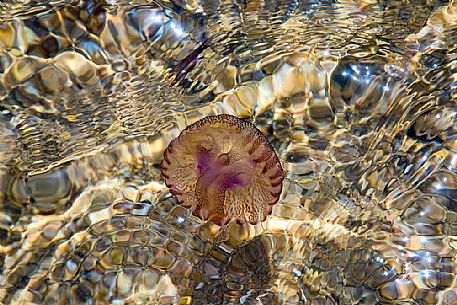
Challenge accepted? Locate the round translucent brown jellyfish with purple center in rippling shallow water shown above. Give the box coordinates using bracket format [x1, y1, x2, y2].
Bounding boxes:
[161, 114, 284, 226]
